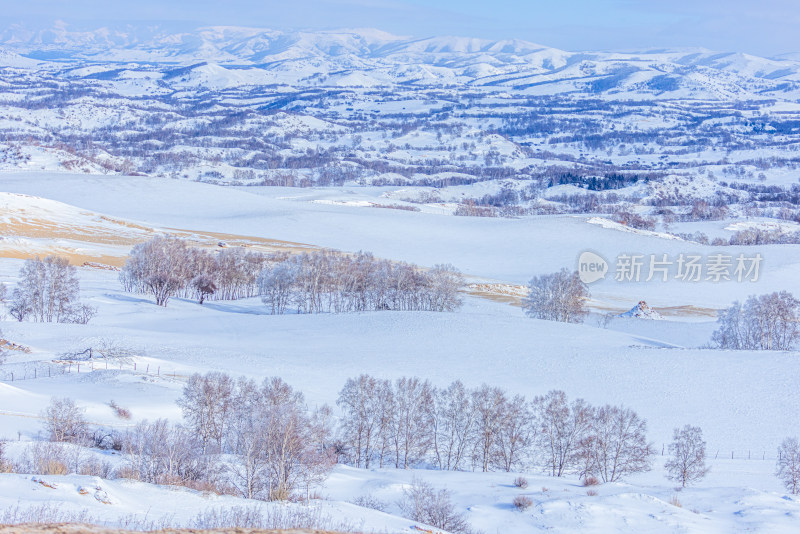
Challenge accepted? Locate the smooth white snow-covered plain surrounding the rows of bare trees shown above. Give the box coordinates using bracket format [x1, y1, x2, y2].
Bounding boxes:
[0, 173, 800, 533]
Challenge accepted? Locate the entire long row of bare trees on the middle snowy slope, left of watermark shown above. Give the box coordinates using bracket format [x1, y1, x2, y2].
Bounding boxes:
[120, 236, 463, 314]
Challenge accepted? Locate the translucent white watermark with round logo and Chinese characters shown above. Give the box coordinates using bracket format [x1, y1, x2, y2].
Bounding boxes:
[578, 251, 764, 284]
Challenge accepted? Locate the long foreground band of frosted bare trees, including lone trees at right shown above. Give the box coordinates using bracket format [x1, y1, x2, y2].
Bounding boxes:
[12, 372, 800, 506]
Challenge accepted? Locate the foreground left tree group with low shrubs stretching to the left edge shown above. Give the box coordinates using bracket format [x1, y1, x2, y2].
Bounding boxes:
[21, 384, 336, 500]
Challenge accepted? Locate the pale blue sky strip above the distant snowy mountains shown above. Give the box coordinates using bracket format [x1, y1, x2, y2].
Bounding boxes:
[0, 0, 800, 56]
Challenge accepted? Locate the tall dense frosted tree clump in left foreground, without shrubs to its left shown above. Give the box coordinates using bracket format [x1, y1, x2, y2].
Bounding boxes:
[165, 373, 335, 500]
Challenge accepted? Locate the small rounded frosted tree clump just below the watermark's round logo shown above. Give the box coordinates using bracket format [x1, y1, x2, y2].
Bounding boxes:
[522, 269, 589, 323]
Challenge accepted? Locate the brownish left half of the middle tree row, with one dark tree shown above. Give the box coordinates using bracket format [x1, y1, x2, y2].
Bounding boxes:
[120, 236, 285, 306]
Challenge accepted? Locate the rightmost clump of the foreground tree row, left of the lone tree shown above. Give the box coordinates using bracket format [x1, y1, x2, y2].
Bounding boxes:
[581, 405, 654, 482]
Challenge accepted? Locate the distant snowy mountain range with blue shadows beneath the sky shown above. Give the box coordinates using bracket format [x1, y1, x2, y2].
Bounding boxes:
[0, 27, 800, 100]
